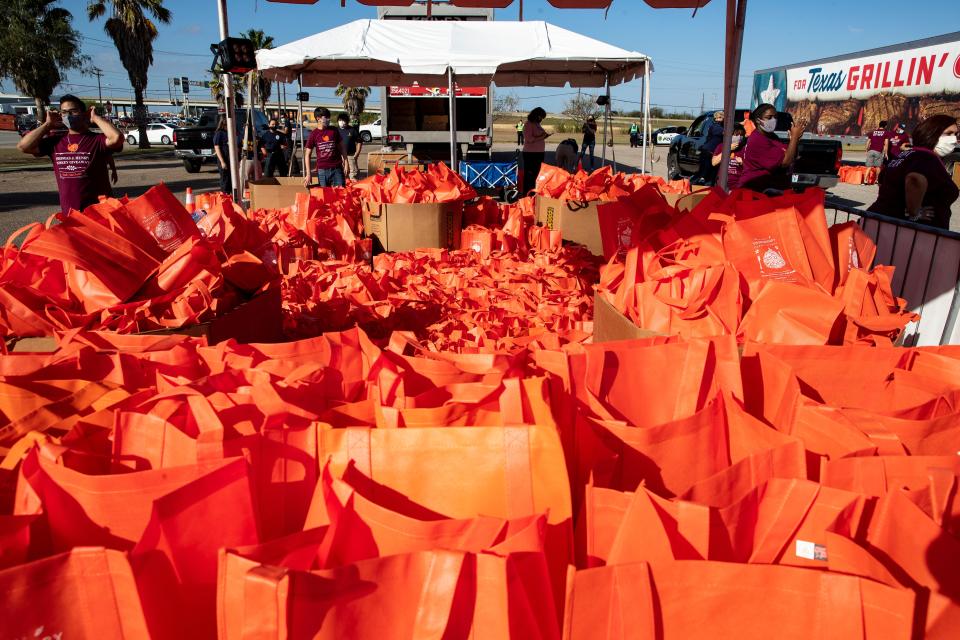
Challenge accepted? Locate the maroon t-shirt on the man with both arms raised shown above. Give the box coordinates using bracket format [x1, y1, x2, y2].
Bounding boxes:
[40, 131, 113, 214]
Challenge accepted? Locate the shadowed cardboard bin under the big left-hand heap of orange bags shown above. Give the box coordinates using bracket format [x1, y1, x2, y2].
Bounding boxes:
[10, 287, 285, 353]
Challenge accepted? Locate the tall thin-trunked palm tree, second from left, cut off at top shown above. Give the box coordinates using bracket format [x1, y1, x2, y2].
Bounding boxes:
[87, 0, 172, 149]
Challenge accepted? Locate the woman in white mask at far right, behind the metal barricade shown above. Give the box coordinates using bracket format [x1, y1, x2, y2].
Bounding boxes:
[869, 114, 960, 229]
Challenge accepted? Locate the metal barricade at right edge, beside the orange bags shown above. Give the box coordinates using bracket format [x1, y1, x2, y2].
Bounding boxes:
[824, 200, 960, 346]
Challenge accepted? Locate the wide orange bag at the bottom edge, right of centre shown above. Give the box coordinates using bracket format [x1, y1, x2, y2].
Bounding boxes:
[564, 560, 914, 640]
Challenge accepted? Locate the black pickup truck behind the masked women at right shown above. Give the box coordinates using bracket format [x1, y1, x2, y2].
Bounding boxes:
[667, 109, 843, 190]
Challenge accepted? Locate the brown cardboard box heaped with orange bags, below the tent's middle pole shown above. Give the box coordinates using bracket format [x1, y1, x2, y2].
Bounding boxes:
[363, 201, 463, 251]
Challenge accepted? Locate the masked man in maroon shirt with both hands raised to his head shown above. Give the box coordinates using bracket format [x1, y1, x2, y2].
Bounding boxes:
[17, 95, 123, 215]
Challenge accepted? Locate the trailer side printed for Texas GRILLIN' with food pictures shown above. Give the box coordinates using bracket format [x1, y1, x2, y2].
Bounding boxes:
[753, 32, 960, 141]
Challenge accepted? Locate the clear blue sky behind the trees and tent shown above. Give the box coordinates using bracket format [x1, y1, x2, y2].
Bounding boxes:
[48, 0, 960, 111]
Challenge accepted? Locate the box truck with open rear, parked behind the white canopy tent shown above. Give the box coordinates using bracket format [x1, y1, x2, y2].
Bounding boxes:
[377, 2, 493, 159]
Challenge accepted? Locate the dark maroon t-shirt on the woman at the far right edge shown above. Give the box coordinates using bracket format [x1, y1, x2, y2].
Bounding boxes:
[869, 147, 960, 229]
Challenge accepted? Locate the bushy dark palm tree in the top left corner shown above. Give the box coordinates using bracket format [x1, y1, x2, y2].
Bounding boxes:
[0, 0, 89, 122]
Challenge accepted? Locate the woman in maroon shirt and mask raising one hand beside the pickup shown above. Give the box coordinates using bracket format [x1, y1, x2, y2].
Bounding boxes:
[740, 103, 807, 191]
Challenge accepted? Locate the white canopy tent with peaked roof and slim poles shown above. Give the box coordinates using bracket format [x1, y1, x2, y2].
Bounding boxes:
[257, 20, 653, 185]
